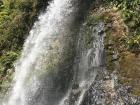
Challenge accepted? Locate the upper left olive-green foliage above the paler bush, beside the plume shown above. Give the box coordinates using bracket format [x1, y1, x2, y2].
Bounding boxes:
[0, 0, 48, 50]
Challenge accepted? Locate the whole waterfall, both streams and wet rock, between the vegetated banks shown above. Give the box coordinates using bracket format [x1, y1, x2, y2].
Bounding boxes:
[0, 0, 140, 105]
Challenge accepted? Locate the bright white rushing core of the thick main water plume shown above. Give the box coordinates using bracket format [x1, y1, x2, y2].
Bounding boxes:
[2, 0, 75, 105]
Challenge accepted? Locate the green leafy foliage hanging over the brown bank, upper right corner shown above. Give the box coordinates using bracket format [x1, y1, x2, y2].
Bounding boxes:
[106, 0, 140, 51]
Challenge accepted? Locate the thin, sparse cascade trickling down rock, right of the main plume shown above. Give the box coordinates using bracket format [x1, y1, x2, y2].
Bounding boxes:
[59, 22, 105, 105]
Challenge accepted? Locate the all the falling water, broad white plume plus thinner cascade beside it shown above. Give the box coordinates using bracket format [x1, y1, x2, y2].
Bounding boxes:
[2, 0, 104, 105]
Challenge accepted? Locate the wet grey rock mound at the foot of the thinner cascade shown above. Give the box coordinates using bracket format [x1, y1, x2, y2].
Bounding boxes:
[81, 71, 140, 105]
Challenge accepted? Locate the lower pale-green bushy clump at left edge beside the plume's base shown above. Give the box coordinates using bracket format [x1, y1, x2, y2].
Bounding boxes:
[0, 52, 19, 91]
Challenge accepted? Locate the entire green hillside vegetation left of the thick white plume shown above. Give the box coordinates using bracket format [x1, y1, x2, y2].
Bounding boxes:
[0, 0, 47, 90]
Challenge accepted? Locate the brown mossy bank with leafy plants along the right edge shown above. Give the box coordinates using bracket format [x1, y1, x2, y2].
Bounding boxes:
[103, 0, 140, 96]
